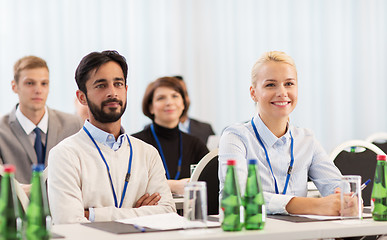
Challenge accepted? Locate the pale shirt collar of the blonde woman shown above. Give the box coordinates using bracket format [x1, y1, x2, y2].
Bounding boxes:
[254, 114, 290, 147]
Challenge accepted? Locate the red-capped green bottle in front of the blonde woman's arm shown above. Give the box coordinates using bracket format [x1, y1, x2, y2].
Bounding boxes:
[220, 160, 243, 231]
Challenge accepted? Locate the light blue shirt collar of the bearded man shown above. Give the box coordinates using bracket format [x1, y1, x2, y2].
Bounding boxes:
[84, 120, 126, 150]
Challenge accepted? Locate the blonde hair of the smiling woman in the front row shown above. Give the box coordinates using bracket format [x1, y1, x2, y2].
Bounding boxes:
[251, 51, 296, 86]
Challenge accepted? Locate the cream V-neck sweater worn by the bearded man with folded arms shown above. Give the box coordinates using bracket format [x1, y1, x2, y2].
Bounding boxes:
[48, 130, 176, 224]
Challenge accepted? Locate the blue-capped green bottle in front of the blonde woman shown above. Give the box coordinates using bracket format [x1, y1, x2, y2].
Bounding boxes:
[244, 159, 266, 230]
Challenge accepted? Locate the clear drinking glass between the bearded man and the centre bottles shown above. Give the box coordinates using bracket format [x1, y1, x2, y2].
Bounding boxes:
[184, 182, 207, 228]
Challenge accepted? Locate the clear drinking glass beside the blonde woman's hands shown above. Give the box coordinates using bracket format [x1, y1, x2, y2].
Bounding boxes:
[340, 175, 363, 219]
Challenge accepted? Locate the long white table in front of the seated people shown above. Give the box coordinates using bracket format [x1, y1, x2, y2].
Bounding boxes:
[53, 218, 387, 240]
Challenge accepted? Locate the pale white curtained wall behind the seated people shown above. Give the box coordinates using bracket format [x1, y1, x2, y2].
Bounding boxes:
[0, 0, 387, 151]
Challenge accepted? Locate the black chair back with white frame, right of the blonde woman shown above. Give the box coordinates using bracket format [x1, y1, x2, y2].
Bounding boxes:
[330, 140, 385, 206]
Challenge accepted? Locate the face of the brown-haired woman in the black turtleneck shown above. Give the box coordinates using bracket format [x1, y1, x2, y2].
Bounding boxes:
[149, 87, 184, 128]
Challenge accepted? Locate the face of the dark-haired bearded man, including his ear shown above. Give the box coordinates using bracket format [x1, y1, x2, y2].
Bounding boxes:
[77, 61, 127, 124]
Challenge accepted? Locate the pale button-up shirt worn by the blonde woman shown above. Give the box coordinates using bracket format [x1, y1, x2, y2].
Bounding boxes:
[219, 115, 342, 214]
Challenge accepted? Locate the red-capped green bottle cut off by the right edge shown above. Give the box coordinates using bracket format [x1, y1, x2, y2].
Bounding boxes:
[371, 155, 387, 221]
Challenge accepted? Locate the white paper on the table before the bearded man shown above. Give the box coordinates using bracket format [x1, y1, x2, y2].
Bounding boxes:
[117, 213, 220, 230]
